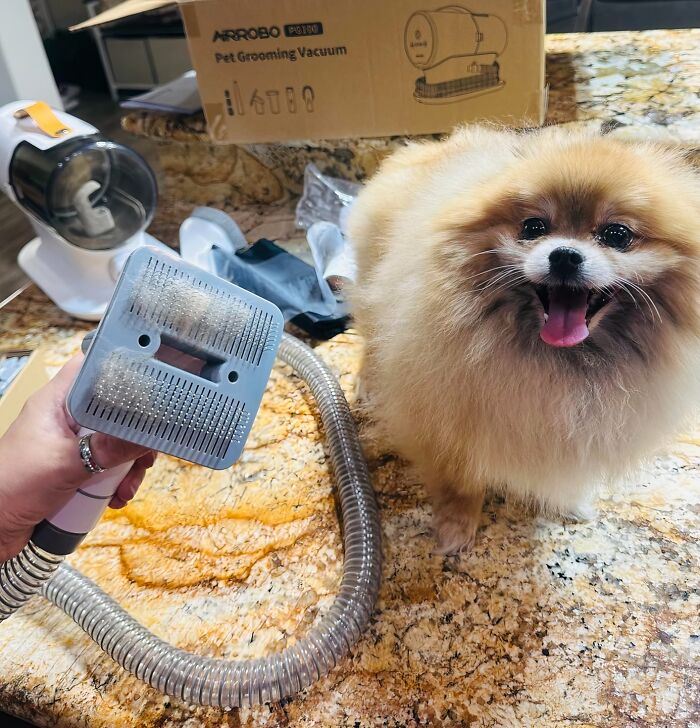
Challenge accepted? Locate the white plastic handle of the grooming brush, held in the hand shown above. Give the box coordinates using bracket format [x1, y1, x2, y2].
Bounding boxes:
[32, 428, 134, 556]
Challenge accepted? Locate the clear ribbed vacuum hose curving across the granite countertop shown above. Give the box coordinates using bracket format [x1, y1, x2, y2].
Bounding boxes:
[0, 334, 381, 708]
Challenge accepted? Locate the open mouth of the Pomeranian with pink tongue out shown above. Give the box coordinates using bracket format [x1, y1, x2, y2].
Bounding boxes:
[535, 285, 615, 347]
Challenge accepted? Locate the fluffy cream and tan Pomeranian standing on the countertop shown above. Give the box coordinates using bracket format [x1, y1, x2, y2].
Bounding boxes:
[349, 127, 700, 553]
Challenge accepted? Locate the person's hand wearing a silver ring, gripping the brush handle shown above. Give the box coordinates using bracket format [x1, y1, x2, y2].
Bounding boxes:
[0, 355, 155, 562]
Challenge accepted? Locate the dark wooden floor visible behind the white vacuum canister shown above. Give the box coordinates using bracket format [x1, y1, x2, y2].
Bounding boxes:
[0, 95, 156, 304]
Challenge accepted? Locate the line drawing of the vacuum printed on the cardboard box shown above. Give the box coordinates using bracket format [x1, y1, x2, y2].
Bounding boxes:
[404, 5, 508, 104]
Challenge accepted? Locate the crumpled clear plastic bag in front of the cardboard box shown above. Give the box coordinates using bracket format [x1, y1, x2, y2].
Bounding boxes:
[296, 164, 362, 230]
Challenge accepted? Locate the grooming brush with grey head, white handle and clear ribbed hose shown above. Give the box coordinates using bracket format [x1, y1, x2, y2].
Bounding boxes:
[0, 248, 381, 707]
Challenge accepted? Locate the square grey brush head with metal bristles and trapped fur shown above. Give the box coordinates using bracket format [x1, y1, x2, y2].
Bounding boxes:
[68, 248, 284, 469]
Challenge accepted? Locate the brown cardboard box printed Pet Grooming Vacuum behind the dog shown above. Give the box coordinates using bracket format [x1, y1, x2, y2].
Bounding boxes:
[76, 0, 546, 143]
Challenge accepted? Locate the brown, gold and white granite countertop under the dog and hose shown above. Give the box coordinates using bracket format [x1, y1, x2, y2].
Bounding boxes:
[0, 31, 700, 728]
